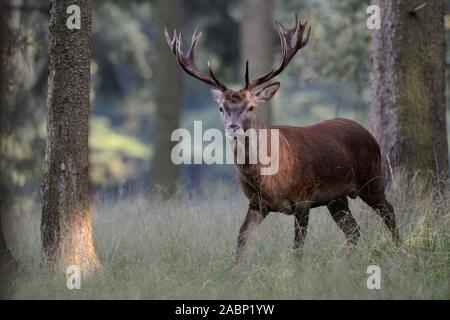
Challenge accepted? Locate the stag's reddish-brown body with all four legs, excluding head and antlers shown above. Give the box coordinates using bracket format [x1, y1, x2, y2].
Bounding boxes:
[232, 115, 399, 262]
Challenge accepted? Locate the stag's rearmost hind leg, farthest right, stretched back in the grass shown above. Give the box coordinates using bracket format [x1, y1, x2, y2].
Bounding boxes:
[359, 179, 401, 245]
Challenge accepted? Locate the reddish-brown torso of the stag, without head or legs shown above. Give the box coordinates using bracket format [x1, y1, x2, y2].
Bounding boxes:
[237, 119, 381, 214]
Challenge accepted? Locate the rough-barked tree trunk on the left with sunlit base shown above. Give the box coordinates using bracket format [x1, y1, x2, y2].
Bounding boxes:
[41, 0, 100, 273]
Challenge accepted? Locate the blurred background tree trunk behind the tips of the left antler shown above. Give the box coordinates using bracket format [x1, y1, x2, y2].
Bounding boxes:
[152, 0, 184, 195]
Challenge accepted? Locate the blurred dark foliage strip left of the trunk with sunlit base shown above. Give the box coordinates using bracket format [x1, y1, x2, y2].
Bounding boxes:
[0, 11, 48, 189]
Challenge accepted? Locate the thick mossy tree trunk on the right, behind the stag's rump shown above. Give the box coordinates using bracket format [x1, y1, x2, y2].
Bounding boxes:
[369, 0, 448, 182]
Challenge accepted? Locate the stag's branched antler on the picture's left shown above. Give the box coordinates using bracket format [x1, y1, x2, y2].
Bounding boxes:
[164, 29, 228, 91]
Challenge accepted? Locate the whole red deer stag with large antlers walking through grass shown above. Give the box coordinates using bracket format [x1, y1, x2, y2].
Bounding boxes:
[166, 15, 399, 263]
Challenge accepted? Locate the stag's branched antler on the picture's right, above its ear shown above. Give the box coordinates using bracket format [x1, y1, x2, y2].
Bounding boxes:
[245, 14, 311, 90]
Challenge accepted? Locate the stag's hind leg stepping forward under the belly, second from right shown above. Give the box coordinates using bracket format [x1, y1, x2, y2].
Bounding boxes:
[327, 197, 360, 250]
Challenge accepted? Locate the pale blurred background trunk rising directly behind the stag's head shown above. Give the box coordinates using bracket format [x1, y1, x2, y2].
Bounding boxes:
[241, 0, 274, 125]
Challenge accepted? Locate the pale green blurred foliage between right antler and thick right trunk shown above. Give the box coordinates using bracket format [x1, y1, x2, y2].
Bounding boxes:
[278, 0, 370, 86]
